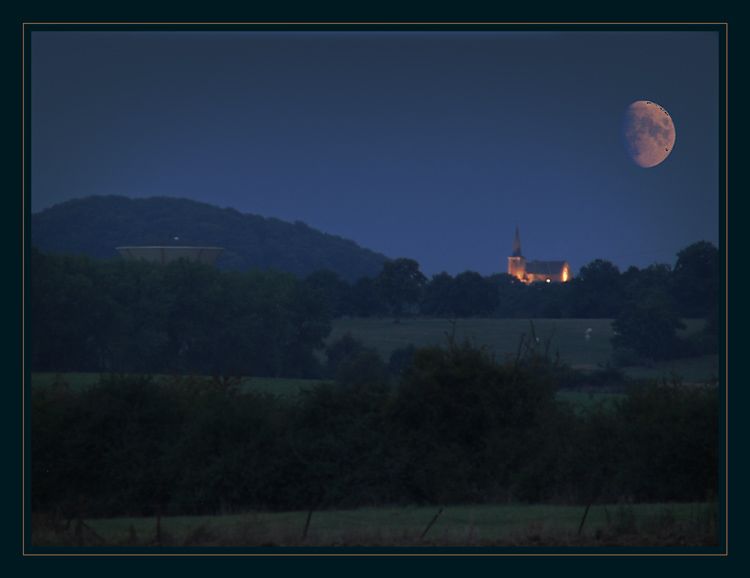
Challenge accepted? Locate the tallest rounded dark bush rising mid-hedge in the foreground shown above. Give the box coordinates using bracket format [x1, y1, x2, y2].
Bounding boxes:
[391, 342, 554, 503]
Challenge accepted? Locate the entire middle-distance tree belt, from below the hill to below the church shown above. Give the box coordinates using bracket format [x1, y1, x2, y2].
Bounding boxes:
[29, 241, 720, 378]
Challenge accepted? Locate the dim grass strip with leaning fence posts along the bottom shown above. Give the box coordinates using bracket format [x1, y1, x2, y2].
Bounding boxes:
[32, 503, 719, 547]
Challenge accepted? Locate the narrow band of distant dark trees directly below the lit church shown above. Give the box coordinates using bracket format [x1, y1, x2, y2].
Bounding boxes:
[296, 241, 720, 319]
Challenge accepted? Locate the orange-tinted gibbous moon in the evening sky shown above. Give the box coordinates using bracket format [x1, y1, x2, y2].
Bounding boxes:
[621, 100, 675, 168]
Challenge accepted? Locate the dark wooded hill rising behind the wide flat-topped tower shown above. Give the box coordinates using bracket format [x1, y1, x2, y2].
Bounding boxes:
[31, 195, 387, 281]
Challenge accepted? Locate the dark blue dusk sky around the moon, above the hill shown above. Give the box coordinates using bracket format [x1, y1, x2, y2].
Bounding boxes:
[31, 31, 720, 276]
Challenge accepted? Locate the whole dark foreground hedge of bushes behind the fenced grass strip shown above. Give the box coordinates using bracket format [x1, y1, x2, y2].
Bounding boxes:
[30, 340, 719, 518]
